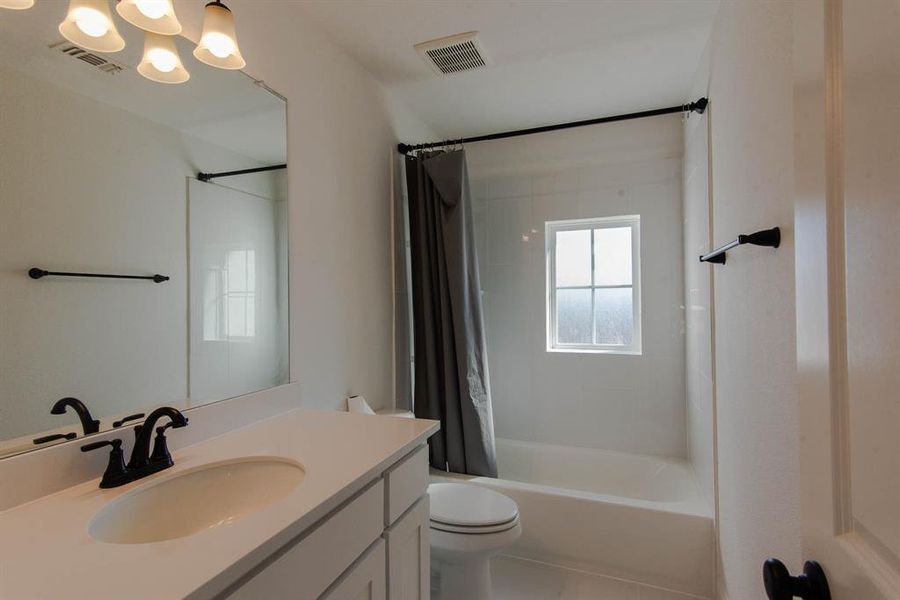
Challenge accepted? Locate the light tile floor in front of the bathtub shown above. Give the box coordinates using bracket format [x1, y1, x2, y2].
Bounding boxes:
[431, 556, 704, 600]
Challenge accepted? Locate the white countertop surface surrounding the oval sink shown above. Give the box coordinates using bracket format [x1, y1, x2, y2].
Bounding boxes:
[0, 409, 438, 599]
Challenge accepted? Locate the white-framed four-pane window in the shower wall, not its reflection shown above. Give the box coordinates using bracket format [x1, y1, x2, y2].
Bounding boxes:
[546, 215, 641, 354]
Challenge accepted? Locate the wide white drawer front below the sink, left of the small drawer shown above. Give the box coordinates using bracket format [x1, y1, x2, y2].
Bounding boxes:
[229, 480, 384, 600]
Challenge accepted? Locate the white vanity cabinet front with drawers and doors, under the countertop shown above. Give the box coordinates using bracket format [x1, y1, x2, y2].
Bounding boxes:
[229, 446, 430, 600]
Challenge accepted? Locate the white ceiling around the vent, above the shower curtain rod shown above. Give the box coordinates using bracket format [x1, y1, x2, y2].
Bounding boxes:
[298, 0, 719, 141]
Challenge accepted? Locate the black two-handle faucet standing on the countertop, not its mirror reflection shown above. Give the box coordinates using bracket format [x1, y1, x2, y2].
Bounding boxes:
[81, 406, 188, 488]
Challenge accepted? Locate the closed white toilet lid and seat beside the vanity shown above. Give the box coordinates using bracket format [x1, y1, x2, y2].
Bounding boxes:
[428, 483, 519, 527]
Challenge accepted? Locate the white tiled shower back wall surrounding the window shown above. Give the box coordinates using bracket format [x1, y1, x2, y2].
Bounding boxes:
[466, 115, 686, 457]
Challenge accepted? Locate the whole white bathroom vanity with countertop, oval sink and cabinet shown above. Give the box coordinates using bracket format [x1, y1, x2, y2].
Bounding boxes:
[0, 409, 438, 600]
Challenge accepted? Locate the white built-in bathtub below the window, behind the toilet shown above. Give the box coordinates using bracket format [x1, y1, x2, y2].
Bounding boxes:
[432, 439, 715, 598]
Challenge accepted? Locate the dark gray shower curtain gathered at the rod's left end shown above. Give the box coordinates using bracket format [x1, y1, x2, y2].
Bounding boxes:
[406, 150, 497, 477]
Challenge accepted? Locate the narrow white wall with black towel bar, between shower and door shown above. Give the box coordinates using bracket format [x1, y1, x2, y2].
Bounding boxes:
[709, 1, 801, 600]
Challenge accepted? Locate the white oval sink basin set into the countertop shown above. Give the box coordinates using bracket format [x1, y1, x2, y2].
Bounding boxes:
[88, 457, 306, 544]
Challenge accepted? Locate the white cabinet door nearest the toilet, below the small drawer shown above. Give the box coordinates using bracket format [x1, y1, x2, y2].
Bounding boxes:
[384, 494, 431, 600]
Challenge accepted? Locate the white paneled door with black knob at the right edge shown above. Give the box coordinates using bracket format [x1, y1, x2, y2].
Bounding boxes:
[794, 0, 900, 600]
